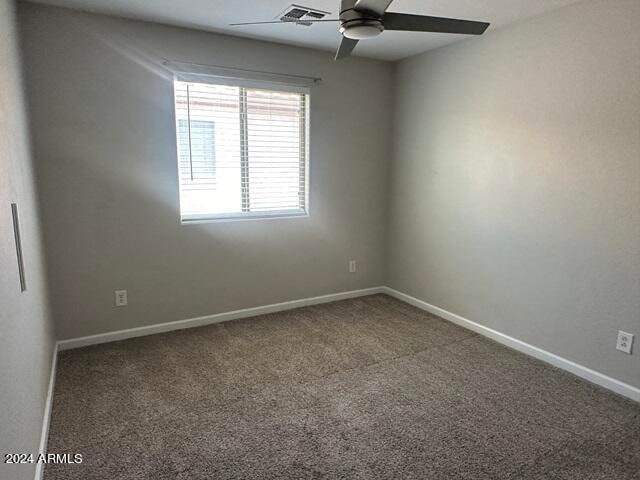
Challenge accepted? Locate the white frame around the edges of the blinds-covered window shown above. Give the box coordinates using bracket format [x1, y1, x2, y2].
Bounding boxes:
[173, 73, 311, 225]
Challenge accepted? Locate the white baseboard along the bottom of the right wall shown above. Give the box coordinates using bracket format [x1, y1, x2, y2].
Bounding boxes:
[383, 287, 640, 402]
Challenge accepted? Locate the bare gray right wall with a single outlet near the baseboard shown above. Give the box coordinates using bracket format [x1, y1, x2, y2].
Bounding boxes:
[388, 0, 640, 387]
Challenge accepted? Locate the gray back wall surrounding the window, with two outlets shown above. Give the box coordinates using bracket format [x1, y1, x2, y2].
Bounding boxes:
[21, 4, 392, 339]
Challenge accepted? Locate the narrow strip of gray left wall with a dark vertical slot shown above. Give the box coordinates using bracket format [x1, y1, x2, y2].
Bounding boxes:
[0, 0, 53, 480]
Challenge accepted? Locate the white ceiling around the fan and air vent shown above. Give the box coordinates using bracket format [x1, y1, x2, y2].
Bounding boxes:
[27, 0, 581, 60]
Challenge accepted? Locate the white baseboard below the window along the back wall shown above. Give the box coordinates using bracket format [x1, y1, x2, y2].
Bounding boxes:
[58, 287, 384, 350]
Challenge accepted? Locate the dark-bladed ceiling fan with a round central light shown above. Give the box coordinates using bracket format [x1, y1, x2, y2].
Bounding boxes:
[231, 0, 489, 60]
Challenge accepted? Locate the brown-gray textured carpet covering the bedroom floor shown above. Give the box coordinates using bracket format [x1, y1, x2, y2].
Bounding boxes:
[45, 295, 640, 480]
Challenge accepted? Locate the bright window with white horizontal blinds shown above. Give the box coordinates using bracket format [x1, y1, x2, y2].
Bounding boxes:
[174, 79, 309, 223]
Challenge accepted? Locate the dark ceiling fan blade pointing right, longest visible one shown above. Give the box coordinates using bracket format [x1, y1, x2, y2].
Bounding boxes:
[382, 13, 490, 35]
